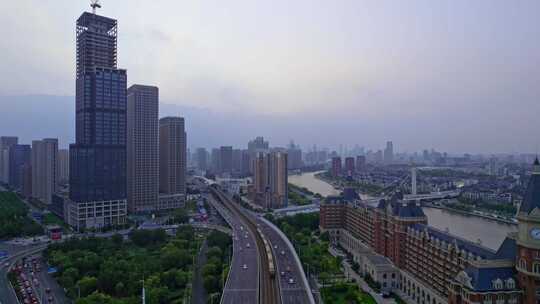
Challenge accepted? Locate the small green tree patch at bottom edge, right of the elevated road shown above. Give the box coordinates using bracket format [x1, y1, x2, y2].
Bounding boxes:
[321, 283, 376, 304]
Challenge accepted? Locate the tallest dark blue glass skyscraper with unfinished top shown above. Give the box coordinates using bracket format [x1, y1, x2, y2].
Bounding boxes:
[65, 8, 127, 229]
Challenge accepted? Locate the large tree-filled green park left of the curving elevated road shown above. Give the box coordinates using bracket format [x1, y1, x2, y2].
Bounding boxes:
[44, 226, 202, 304]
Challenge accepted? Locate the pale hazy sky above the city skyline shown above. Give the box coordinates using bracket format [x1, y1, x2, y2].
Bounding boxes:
[0, 0, 540, 152]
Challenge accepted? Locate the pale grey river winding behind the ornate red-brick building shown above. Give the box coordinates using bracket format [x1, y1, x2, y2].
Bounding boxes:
[289, 172, 517, 250]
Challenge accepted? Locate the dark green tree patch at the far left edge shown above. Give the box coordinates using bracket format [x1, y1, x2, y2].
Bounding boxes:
[0, 191, 43, 239]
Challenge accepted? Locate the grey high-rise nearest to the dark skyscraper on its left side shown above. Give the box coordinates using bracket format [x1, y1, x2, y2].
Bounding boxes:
[31, 138, 58, 204]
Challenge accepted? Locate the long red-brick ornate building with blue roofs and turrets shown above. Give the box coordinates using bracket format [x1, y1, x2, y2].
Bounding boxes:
[320, 159, 540, 304]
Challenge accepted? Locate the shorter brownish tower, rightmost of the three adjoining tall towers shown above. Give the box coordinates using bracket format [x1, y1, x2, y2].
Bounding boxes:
[159, 117, 187, 195]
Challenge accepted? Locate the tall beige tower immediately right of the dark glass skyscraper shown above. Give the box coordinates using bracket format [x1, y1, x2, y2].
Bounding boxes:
[127, 85, 159, 213]
